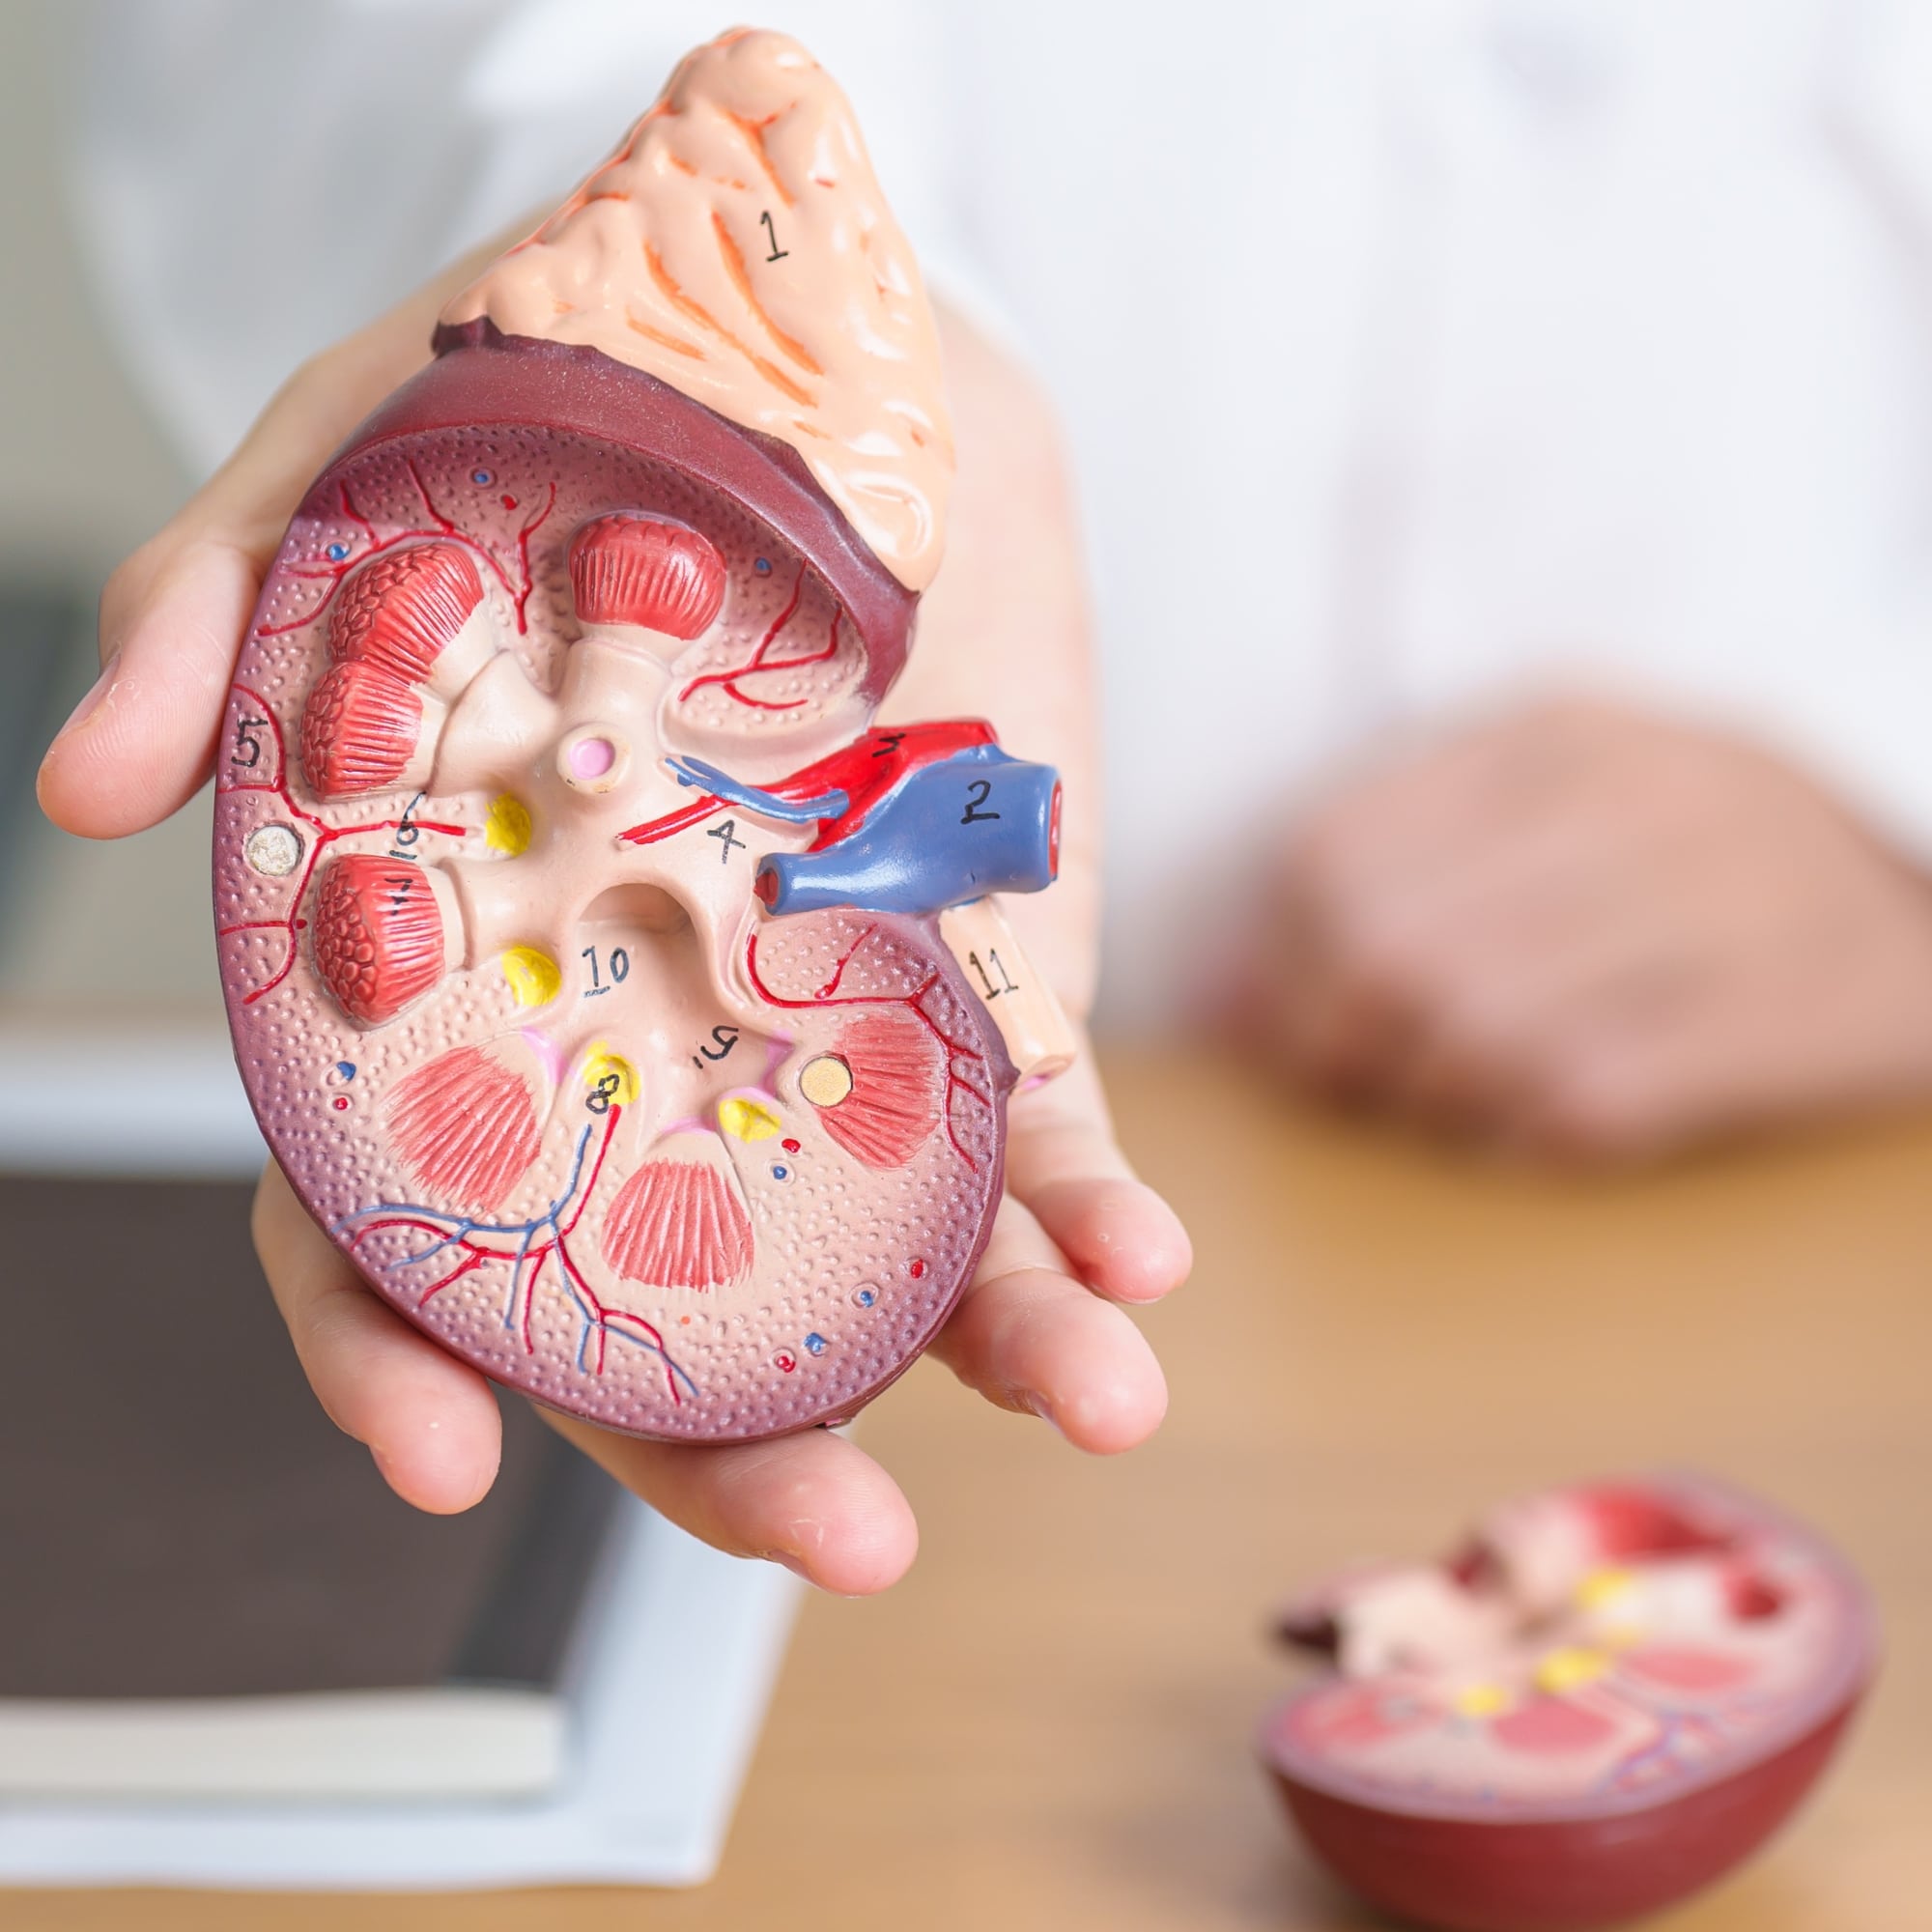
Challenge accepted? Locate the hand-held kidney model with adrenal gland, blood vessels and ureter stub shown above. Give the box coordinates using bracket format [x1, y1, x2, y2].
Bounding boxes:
[214, 33, 1070, 1441]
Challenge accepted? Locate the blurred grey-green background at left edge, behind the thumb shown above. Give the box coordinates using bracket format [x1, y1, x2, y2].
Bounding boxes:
[0, 0, 207, 1024]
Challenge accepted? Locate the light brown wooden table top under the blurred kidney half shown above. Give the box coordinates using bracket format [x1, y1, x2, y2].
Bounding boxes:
[22, 1055, 1932, 1932]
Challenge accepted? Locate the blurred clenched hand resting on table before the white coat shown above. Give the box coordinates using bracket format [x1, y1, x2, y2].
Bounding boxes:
[1256, 701, 1932, 1159]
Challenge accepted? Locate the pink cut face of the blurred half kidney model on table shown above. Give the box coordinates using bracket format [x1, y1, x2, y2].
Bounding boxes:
[1277, 1478, 1872, 1818]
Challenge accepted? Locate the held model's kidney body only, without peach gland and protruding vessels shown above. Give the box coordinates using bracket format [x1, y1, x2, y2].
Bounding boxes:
[214, 330, 1012, 1441]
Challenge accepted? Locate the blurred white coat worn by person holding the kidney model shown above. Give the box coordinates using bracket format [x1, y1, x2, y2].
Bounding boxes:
[75, 0, 1932, 1022]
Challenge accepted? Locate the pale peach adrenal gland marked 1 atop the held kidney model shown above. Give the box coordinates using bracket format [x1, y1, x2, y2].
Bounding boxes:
[442, 29, 952, 591]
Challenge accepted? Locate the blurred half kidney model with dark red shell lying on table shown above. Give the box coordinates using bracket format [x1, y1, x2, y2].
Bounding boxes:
[1262, 1476, 1876, 1932]
